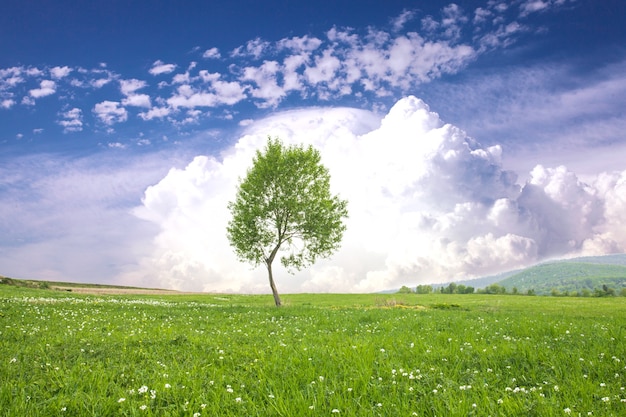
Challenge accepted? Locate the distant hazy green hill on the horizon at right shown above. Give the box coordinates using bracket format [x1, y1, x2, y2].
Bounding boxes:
[499, 262, 626, 295]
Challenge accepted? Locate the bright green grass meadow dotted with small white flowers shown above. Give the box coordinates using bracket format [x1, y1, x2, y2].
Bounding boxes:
[0, 286, 626, 417]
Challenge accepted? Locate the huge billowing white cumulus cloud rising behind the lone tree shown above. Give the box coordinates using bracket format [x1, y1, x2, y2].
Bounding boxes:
[126, 97, 626, 292]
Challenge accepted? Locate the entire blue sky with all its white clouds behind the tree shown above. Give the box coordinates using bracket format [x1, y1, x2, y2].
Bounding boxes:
[0, 0, 626, 293]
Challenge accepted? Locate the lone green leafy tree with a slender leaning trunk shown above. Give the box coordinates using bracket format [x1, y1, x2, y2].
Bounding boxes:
[227, 137, 348, 306]
